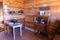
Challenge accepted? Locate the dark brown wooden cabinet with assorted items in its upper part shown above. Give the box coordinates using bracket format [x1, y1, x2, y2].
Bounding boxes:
[35, 16, 48, 32]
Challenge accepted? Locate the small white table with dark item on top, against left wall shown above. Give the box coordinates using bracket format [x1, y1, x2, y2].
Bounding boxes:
[6, 22, 22, 40]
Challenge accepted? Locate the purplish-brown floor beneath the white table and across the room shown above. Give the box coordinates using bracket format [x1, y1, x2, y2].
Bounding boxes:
[0, 29, 60, 40]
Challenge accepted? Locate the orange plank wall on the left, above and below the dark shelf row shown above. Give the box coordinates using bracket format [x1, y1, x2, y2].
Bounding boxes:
[3, 0, 24, 20]
